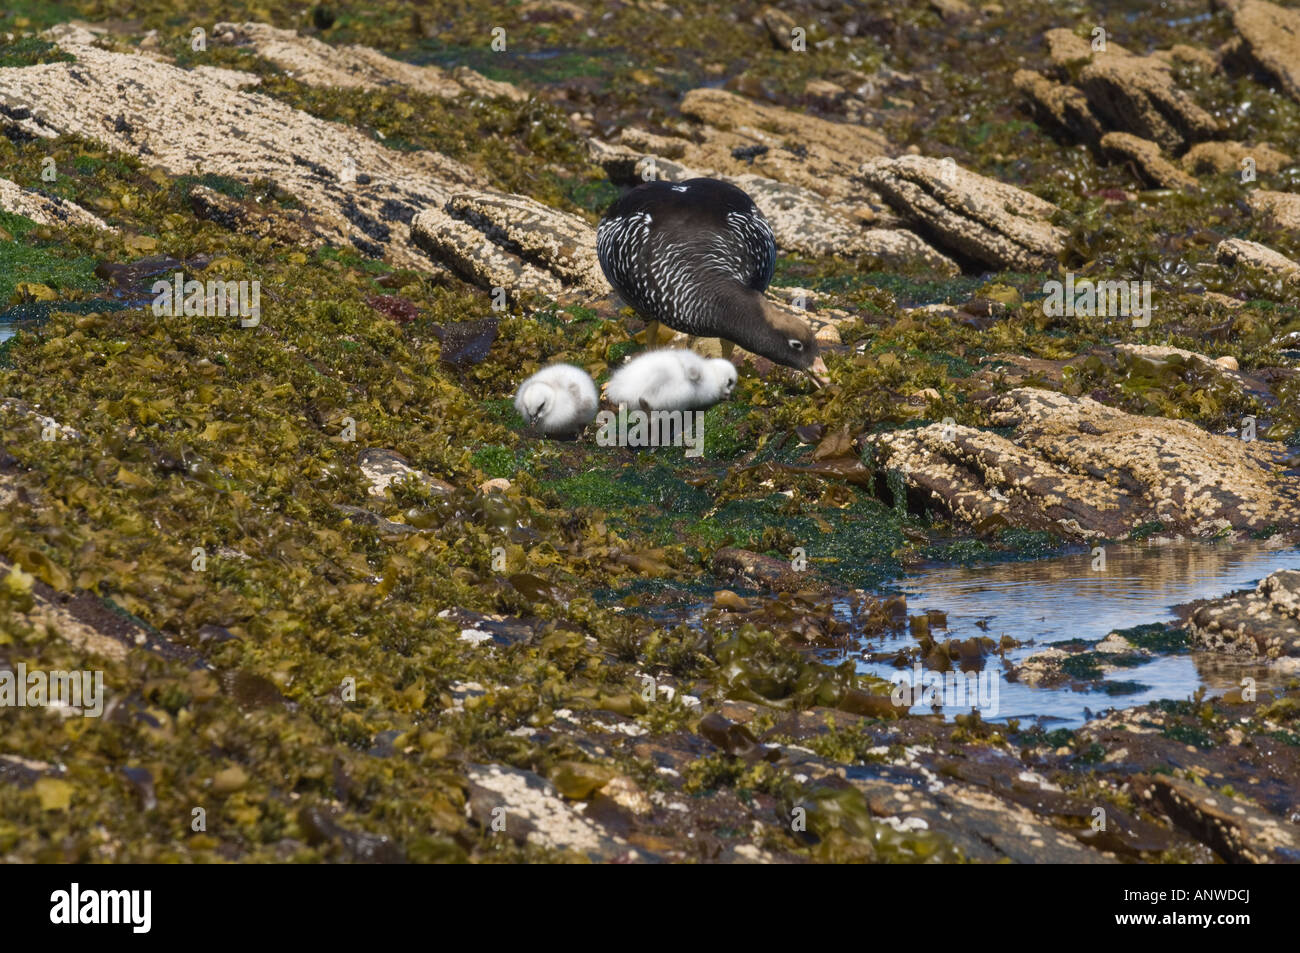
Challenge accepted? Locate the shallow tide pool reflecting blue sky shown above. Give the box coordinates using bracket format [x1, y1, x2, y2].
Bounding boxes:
[842, 542, 1300, 727]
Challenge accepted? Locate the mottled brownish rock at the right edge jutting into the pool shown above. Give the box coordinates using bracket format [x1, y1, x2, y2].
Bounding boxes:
[1188, 569, 1300, 672]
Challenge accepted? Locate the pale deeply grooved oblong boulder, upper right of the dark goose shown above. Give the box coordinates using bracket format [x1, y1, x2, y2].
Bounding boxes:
[859, 156, 1066, 270]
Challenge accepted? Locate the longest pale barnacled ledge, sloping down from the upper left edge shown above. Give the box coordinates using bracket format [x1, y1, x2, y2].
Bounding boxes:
[0, 46, 478, 267]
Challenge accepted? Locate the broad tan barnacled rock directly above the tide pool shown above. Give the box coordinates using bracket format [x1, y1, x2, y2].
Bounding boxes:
[872, 387, 1300, 540]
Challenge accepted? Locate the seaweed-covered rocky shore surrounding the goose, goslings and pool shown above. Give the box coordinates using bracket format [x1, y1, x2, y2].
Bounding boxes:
[0, 0, 1300, 863]
